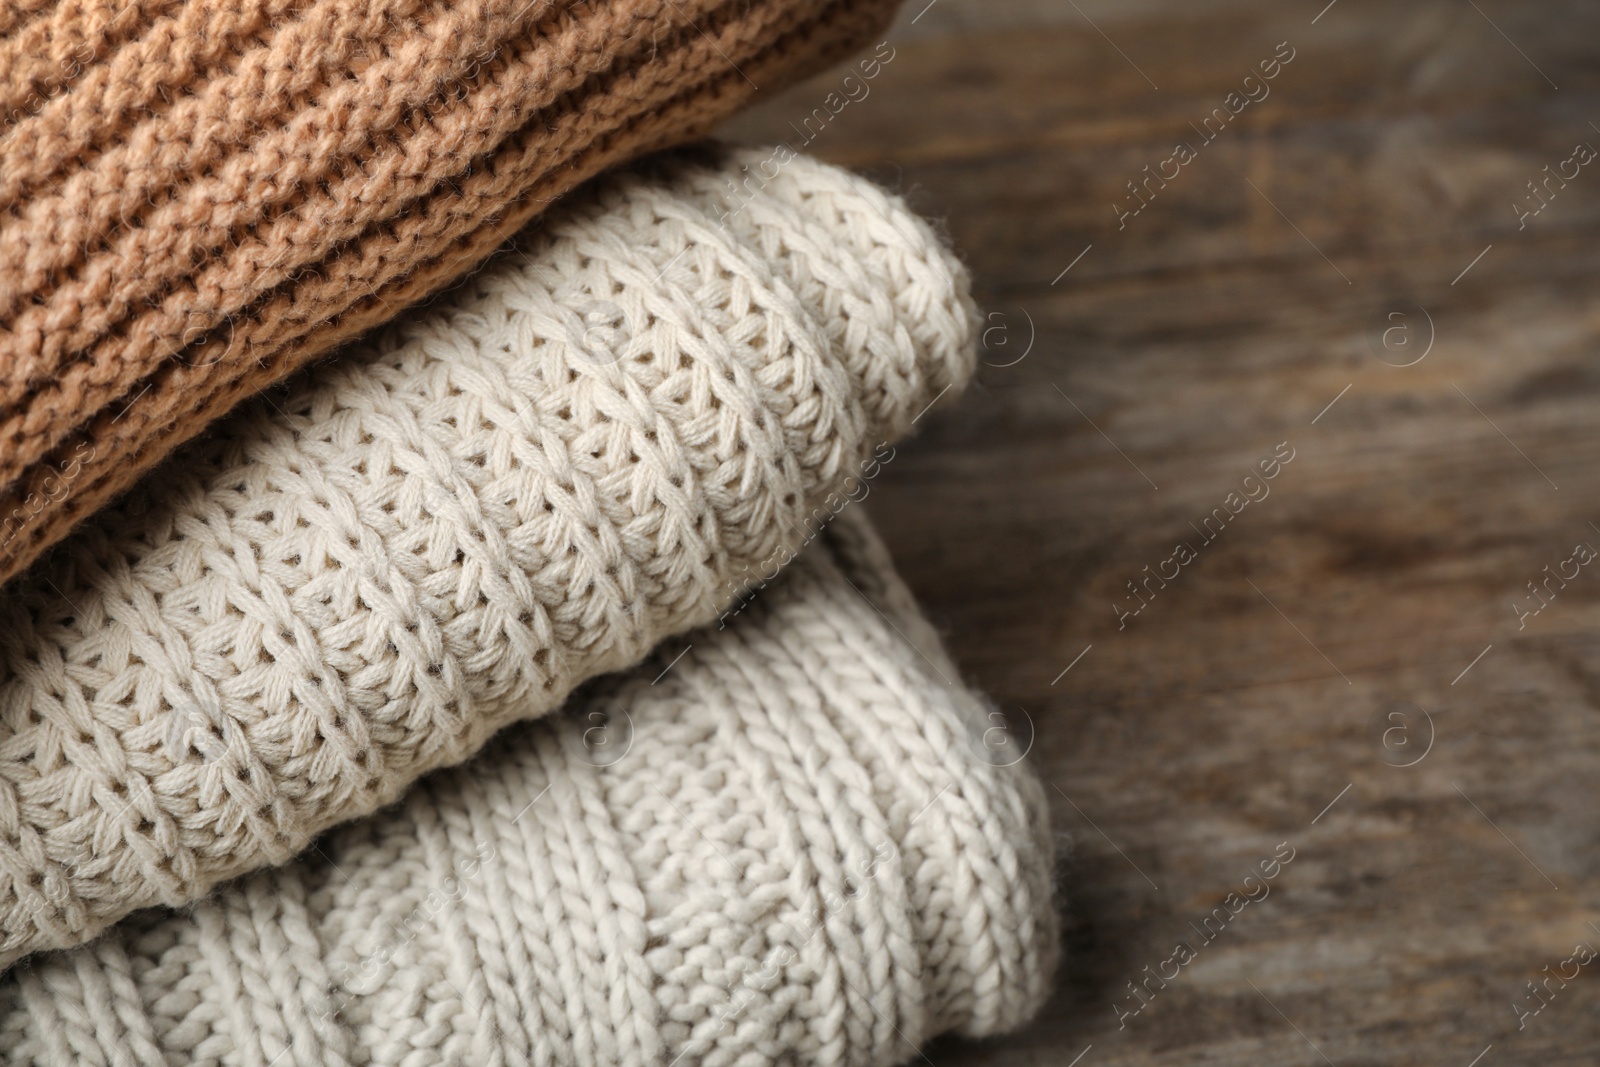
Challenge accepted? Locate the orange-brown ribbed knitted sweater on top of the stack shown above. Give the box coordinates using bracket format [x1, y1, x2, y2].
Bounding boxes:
[0, 0, 894, 581]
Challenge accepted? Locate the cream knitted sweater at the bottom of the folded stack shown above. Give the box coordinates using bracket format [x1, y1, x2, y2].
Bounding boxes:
[0, 509, 1058, 1067]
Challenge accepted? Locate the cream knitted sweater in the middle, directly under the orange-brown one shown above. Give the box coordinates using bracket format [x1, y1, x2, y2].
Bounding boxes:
[0, 152, 976, 965]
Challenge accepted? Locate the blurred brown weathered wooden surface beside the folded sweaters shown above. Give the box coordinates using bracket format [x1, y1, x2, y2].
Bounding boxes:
[725, 0, 1600, 1067]
